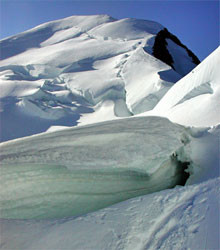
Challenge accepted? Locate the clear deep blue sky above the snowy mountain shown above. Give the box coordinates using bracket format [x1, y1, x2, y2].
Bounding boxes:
[0, 0, 220, 60]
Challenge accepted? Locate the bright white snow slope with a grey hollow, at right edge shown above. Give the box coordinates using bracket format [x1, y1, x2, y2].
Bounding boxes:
[151, 48, 220, 126]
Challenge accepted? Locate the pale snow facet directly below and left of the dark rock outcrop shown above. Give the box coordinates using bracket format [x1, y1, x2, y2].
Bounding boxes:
[121, 48, 180, 114]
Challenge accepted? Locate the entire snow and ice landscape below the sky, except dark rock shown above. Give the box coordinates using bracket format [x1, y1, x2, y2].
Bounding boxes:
[0, 15, 220, 250]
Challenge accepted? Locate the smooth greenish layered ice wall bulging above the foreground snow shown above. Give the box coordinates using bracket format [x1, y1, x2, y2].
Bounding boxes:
[0, 117, 190, 219]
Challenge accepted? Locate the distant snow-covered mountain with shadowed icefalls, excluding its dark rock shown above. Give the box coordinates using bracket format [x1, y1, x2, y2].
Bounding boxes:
[0, 15, 199, 141]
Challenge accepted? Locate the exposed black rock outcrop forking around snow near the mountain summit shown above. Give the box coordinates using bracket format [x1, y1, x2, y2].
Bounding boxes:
[153, 28, 200, 69]
